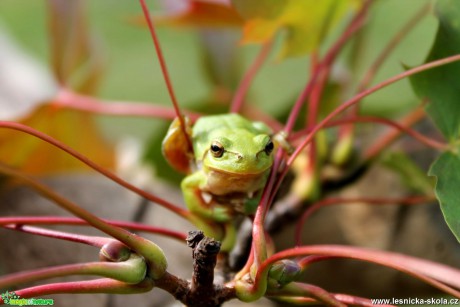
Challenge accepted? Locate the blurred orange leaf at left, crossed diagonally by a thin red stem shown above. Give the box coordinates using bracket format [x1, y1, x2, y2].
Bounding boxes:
[0, 104, 114, 175]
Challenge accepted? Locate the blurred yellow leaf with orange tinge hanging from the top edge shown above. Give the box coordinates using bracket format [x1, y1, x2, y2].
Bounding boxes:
[232, 0, 360, 57]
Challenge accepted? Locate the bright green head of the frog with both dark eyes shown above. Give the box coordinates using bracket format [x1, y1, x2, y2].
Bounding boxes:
[202, 129, 274, 175]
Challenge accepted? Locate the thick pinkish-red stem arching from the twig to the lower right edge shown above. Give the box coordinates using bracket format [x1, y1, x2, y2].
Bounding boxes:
[254, 245, 460, 297]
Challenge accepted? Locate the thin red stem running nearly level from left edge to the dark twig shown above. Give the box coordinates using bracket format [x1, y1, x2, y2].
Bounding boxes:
[0, 216, 187, 242]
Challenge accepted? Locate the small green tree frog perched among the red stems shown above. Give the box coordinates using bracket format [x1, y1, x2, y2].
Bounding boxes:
[162, 113, 275, 250]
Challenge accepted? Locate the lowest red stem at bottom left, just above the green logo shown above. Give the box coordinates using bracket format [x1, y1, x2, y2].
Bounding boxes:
[0, 278, 153, 302]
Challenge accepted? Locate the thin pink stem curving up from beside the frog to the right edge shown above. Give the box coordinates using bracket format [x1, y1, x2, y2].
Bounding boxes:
[287, 54, 460, 166]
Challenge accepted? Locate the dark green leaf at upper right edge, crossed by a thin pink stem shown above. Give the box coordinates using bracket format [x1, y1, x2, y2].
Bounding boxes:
[410, 0, 460, 141]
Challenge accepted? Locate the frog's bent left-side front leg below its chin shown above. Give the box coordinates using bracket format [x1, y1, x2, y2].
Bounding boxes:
[181, 171, 233, 223]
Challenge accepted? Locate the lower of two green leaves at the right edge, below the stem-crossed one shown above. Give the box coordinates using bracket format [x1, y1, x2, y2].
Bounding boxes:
[428, 152, 460, 242]
